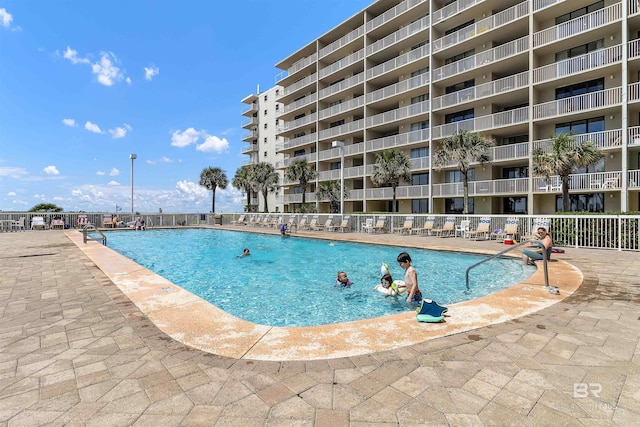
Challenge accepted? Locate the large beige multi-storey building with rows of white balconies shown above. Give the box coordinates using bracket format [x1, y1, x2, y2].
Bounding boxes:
[245, 0, 640, 214]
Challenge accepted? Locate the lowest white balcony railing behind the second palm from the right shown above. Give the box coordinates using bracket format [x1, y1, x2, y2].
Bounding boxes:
[433, 178, 529, 197]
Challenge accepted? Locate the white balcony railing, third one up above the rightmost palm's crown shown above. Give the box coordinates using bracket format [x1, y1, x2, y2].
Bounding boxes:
[533, 3, 622, 48]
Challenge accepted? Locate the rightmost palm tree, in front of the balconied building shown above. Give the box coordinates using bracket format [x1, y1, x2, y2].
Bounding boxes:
[531, 133, 603, 212]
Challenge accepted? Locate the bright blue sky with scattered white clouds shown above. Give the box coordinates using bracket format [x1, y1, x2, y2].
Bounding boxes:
[0, 0, 371, 212]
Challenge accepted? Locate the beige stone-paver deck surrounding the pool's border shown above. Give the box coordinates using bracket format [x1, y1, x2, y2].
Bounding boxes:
[0, 227, 640, 426]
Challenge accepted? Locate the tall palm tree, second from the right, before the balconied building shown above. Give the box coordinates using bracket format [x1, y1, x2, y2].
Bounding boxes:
[433, 130, 495, 214]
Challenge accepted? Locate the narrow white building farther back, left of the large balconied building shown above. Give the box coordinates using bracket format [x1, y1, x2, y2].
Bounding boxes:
[242, 86, 284, 212]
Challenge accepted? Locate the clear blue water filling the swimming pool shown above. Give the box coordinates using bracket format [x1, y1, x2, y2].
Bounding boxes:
[108, 229, 535, 326]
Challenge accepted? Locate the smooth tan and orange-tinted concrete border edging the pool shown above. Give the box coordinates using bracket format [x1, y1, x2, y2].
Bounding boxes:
[66, 227, 583, 361]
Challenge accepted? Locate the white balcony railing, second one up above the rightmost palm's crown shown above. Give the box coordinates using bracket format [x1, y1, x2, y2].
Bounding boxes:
[533, 45, 622, 84]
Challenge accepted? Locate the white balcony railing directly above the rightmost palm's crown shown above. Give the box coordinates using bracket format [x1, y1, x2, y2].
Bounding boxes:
[533, 87, 622, 120]
